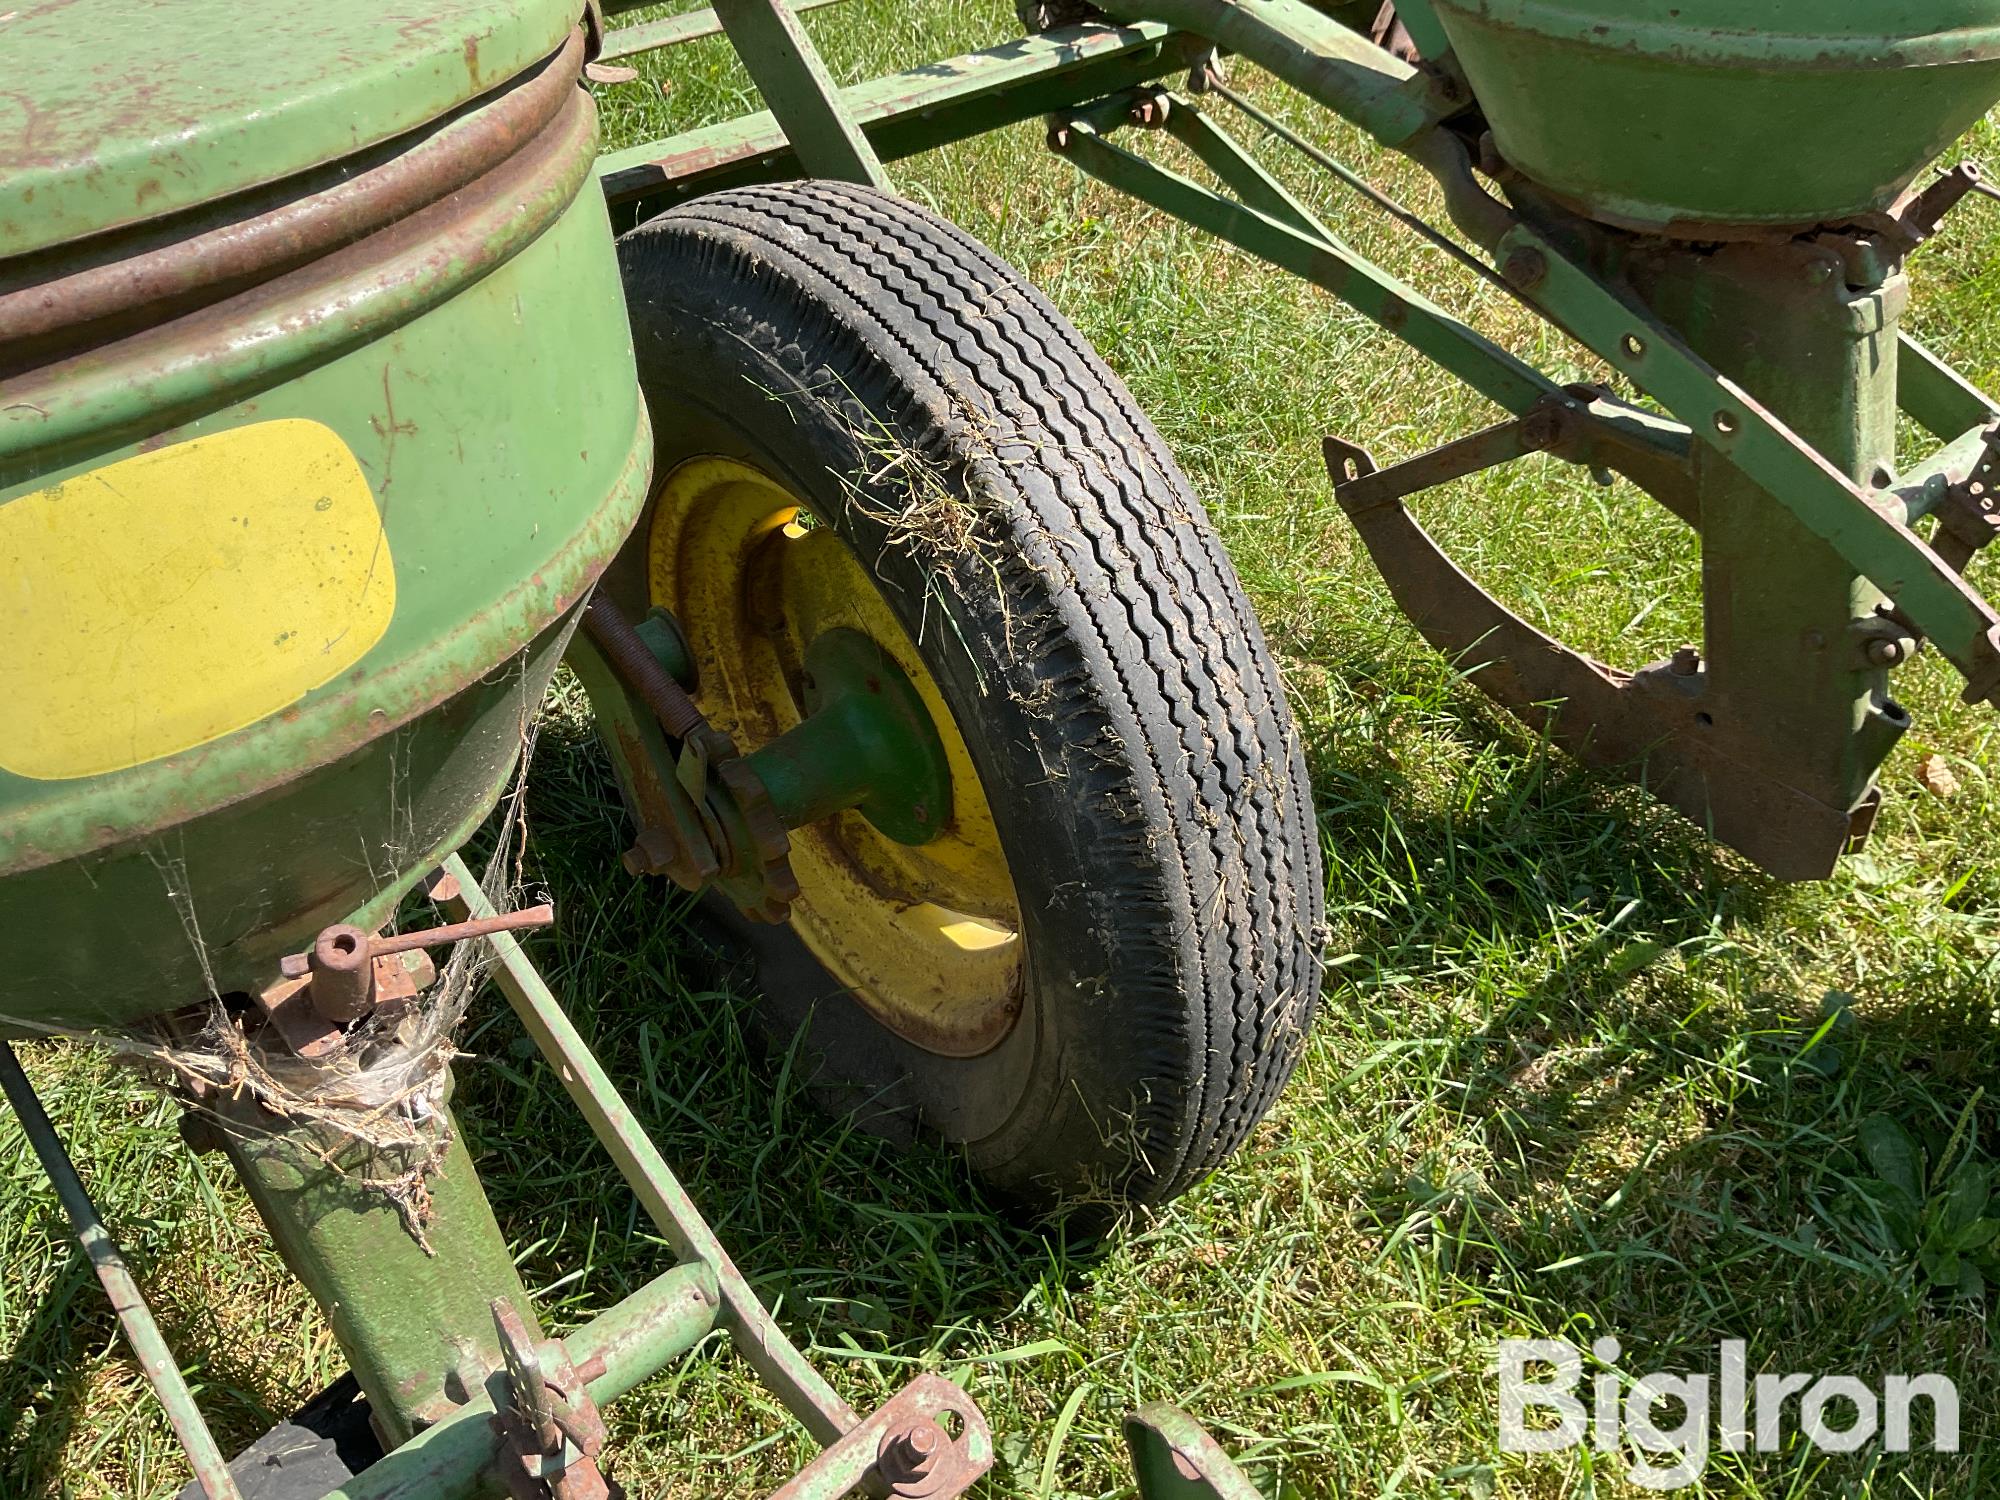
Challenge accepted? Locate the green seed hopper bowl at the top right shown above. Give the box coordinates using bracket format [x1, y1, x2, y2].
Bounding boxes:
[1436, 0, 2000, 240]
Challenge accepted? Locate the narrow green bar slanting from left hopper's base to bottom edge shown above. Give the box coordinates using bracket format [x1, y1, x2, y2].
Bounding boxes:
[444, 854, 860, 1444]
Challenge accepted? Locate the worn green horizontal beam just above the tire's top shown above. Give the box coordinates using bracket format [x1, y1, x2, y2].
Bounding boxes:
[598, 24, 1204, 204]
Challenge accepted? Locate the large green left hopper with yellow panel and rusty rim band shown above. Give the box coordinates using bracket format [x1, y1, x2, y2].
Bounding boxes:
[0, 4, 650, 1028]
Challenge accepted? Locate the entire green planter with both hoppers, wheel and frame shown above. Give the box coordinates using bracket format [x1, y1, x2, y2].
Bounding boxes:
[0, 0, 2000, 1500]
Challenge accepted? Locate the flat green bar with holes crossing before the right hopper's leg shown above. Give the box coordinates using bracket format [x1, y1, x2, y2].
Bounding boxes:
[1496, 226, 2000, 704]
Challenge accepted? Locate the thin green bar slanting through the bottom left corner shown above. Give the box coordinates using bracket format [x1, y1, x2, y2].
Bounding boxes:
[0, 1042, 242, 1500]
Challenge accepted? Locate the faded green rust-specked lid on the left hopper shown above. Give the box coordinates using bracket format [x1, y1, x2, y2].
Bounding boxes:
[0, 0, 582, 258]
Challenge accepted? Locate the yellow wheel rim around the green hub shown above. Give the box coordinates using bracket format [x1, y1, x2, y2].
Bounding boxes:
[646, 458, 1022, 1058]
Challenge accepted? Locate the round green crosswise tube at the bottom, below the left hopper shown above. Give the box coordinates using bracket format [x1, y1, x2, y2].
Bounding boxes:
[328, 1262, 718, 1500]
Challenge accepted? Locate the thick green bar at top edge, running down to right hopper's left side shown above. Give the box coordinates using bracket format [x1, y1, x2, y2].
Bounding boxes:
[1096, 0, 1468, 146]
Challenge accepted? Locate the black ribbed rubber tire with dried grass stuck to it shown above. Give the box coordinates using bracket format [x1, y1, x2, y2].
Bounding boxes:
[608, 182, 1322, 1202]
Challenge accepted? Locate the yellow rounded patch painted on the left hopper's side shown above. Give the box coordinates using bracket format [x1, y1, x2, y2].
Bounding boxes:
[0, 418, 396, 780]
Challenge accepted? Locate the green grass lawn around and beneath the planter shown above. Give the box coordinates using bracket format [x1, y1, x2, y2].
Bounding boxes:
[11, 0, 2000, 1500]
